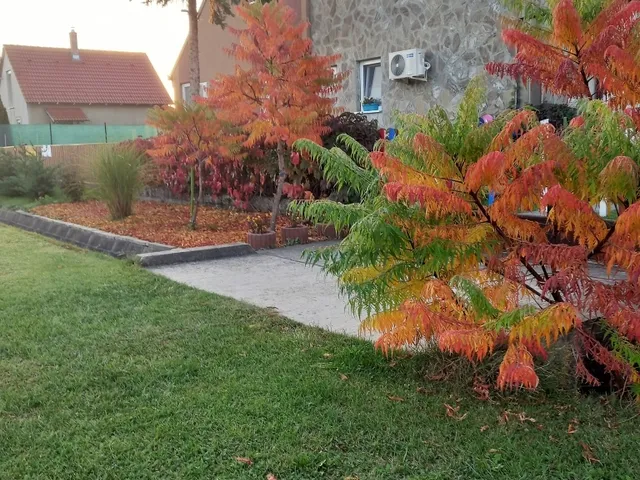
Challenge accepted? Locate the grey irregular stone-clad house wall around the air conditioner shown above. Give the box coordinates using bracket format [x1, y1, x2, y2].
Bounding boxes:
[308, 0, 515, 126]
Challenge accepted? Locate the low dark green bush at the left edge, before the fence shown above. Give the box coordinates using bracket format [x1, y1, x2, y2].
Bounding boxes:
[0, 147, 57, 200]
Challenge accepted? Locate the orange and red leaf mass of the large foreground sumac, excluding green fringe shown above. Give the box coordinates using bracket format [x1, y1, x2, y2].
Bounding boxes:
[358, 102, 640, 389]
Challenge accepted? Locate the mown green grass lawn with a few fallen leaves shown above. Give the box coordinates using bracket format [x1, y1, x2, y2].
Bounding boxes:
[0, 227, 640, 480]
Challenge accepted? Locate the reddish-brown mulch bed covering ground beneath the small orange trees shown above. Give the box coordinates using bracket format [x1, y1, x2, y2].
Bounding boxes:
[31, 201, 324, 248]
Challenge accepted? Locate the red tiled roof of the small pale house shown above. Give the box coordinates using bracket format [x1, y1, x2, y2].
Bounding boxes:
[4, 45, 172, 105]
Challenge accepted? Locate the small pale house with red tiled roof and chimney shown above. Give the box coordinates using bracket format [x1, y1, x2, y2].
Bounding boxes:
[0, 31, 173, 125]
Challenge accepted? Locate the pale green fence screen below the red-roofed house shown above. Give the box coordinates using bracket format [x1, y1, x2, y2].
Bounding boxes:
[0, 123, 158, 147]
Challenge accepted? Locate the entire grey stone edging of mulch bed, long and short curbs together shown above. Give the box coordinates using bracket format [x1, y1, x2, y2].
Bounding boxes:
[0, 208, 255, 267]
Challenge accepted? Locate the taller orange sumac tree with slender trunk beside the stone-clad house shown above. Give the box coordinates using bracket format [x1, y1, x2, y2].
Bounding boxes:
[207, 1, 343, 230]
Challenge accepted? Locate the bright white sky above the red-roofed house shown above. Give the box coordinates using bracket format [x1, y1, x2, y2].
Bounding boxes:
[0, 0, 194, 96]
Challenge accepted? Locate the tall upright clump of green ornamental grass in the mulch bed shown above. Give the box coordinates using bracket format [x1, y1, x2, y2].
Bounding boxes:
[93, 146, 144, 220]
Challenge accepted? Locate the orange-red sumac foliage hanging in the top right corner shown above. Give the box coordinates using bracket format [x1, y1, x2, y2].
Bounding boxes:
[486, 0, 640, 127]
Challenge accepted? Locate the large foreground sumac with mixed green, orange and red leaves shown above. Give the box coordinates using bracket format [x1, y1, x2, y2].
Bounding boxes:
[295, 78, 640, 389]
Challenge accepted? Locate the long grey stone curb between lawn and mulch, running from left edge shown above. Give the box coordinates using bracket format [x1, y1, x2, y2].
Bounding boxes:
[0, 208, 173, 258]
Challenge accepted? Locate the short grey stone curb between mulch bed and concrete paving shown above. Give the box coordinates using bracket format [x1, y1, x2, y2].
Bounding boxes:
[136, 243, 256, 267]
